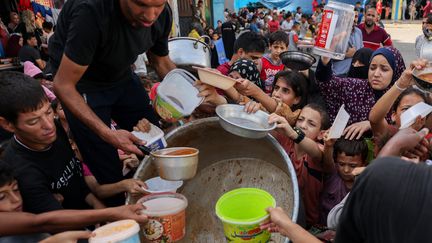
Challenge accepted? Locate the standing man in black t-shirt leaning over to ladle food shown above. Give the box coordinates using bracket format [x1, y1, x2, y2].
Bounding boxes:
[49, 0, 175, 205]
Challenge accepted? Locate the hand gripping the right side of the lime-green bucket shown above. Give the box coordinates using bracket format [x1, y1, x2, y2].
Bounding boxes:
[260, 207, 292, 236]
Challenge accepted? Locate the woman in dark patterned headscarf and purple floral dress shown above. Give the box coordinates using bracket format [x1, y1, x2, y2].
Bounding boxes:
[316, 47, 405, 137]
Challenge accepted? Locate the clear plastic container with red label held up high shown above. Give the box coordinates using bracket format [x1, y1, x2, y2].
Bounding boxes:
[313, 1, 355, 60]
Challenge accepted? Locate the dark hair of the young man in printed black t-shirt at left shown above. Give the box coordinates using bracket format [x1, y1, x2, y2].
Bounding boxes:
[0, 71, 48, 124]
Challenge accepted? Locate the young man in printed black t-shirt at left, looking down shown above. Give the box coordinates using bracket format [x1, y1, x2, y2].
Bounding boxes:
[0, 72, 103, 213]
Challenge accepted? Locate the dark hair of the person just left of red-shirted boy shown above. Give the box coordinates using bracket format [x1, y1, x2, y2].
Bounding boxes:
[234, 31, 266, 53]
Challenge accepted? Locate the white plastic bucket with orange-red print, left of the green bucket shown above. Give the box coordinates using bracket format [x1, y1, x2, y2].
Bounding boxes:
[137, 193, 188, 242]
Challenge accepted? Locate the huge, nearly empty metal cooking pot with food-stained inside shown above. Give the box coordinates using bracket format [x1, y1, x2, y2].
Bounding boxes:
[128, 117, 300, 243]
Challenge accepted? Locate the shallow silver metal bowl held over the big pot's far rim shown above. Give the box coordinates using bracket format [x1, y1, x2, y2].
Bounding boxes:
[216, 104, 276, 138]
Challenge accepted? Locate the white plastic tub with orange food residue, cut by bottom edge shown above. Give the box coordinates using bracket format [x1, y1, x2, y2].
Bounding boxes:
[89, 219, 140, 243]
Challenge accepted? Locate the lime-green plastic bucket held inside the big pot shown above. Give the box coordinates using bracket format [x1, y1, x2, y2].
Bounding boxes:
[216, 188, 276, 242]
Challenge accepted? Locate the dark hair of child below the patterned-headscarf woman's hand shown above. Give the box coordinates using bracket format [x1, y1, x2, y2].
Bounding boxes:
[333, 138, 369, 162]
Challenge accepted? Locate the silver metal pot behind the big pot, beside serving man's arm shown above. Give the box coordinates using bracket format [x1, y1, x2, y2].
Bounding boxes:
[168, 37, 211, 67]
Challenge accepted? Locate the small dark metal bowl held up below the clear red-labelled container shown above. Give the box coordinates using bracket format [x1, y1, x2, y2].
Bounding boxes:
[279, 51, 316, 70]
